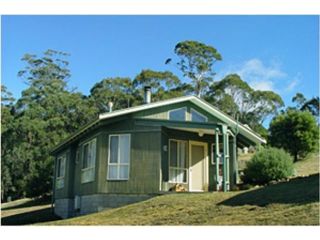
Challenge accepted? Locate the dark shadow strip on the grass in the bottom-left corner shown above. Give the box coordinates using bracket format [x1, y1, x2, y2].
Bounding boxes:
[1, 207, 61, 225]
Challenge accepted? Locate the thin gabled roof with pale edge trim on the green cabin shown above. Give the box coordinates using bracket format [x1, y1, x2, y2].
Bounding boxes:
[52, 96, 266, 152]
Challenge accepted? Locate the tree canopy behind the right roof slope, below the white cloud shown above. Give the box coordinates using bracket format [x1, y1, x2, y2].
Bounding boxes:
[206, 74, 284, 131]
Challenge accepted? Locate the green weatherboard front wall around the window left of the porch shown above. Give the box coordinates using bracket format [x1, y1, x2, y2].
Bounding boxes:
[98, 121, 161, 194]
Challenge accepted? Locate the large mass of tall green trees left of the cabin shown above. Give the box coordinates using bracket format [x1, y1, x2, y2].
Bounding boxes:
[1, 50, 97, 199]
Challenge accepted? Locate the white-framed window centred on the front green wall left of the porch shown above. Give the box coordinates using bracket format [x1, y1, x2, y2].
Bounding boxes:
[107, 134, 130, 180]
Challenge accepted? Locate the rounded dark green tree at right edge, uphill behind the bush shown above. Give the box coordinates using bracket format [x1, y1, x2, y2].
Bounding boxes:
[269, 110, 319, 161]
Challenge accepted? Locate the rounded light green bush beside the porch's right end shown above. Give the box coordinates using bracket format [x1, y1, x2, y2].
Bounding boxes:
[242, 147, 293, 184]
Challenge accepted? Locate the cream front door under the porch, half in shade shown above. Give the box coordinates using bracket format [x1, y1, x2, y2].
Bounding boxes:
[189, 141, 208, 192]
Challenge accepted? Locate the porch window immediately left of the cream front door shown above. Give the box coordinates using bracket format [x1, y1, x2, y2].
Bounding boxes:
[169, 140, 188, 183]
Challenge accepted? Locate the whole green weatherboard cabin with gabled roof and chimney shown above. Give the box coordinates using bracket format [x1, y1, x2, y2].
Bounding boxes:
[52, 89, 265, 218]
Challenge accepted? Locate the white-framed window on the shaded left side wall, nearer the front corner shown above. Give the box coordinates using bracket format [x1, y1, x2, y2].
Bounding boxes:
[81, 138, 97, 183]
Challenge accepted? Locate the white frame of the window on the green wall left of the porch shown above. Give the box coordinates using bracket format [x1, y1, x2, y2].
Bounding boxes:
[107, 133, 131, 181]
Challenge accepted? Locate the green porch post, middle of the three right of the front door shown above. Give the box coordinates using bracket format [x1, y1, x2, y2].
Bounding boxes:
[222, 125, 230, 192]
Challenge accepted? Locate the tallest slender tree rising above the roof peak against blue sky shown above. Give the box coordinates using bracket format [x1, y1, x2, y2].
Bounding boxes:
[171, 41, 222, 97]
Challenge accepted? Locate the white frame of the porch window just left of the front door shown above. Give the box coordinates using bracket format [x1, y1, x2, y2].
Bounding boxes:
[168, 139, 189, 184]
